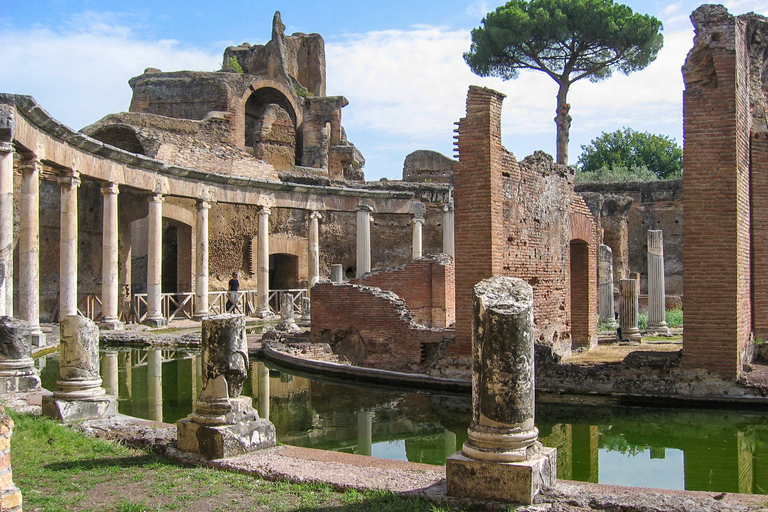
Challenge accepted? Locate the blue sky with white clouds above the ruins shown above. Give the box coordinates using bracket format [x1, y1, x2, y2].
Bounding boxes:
[0, 0, 768, 180]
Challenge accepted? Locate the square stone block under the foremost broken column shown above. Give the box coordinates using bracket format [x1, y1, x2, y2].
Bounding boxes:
[445, 448, 557, 504]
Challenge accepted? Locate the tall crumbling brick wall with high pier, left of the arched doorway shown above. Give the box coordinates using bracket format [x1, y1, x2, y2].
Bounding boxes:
[451, 87, 597, 355]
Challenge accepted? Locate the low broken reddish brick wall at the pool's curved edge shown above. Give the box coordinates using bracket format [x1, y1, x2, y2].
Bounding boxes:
[311, 282, 453, 372]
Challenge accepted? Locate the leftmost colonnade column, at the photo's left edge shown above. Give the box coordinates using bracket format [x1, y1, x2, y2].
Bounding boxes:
[0, 143, 13, 316]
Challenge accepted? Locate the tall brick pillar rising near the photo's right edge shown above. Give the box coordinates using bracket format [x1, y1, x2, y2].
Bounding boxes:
[683, 5, 752, 379]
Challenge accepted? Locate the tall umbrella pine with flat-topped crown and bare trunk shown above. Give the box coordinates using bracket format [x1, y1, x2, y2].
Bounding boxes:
[464, 0, 664, 165]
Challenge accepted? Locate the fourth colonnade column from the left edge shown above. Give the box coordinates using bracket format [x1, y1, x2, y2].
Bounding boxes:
[99, 183, 123, 330]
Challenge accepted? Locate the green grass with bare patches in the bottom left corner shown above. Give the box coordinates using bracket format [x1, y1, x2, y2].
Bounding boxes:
[8, 411, 464, 512]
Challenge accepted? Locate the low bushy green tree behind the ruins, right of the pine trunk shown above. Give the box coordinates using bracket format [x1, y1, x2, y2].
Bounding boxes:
[578, 128, 683, 181]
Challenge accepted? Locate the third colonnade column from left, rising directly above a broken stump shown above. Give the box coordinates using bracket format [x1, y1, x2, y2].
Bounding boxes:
[59, 171, 80, 318]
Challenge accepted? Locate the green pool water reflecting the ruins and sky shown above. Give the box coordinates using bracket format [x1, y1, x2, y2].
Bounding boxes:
[38, 348, 768, 494]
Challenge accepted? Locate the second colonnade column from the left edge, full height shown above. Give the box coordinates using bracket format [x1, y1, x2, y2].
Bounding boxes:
[19, 159, 45, 347]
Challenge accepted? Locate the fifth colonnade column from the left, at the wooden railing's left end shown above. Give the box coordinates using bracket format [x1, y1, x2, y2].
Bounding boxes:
[144, 194, 168, 327]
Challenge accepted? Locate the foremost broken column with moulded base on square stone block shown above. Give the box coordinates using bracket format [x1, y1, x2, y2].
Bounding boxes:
[446, 276, 557, 503]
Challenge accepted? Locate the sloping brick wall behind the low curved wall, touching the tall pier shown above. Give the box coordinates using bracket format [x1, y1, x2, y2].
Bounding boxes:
[350, 254, 456, 328]
